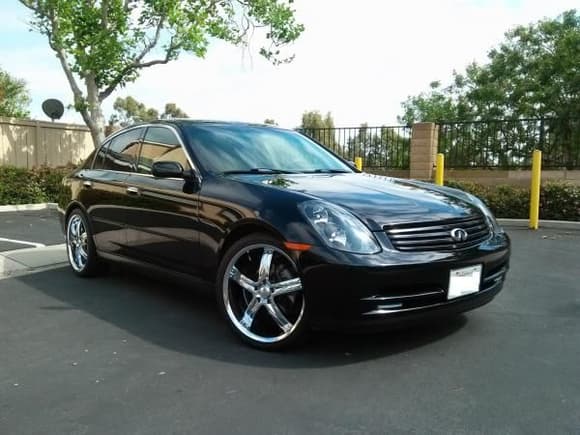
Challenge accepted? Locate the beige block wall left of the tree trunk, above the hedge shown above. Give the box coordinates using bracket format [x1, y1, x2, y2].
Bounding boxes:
[0, 117, 93, 168]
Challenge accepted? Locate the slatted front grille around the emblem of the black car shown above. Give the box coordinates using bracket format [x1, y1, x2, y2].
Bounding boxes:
[383, 215, 490, 252]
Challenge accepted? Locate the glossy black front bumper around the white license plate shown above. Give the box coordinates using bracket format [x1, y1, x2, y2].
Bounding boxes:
[301, 234, 510, 329]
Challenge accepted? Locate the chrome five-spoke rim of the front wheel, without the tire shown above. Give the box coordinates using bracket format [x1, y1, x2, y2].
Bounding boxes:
[222, 243, 304, 343]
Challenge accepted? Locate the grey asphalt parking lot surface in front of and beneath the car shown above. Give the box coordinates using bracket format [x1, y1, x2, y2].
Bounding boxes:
[0, 223, 580, 434]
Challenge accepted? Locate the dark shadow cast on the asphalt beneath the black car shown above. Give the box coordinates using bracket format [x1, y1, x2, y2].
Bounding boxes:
[15, 266, 467, 369]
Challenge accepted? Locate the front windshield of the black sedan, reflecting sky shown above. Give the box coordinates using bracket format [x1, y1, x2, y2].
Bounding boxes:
[184, 124, 352, 173]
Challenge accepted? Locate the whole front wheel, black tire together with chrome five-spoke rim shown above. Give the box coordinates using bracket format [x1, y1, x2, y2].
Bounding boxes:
[216, 234, 309, 350]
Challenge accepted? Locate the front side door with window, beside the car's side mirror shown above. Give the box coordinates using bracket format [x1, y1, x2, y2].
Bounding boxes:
[126, 125, 199, 274]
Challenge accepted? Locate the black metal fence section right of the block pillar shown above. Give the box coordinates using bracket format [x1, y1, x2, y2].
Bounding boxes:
[438, 118, 580, 169]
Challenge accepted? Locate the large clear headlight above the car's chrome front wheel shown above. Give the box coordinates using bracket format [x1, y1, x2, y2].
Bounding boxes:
[298, 201, 381, 254]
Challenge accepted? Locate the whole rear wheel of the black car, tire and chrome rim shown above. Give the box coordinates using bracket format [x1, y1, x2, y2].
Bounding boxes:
[65, 208, 103, 278]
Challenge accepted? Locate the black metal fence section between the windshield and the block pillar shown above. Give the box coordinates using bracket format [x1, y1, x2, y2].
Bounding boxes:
[300, 126, 411, 169]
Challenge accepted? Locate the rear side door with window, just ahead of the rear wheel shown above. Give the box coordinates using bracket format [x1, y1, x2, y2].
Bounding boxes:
[79, 127, 144, 254]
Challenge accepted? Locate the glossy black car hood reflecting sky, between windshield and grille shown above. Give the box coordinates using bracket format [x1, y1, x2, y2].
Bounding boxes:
[225, 173, 478, 231]
